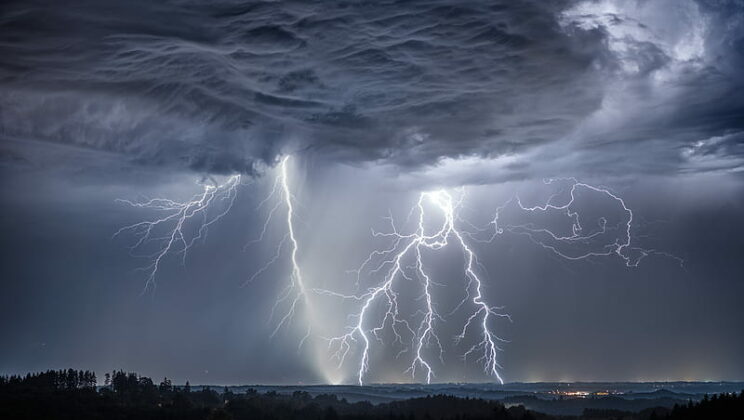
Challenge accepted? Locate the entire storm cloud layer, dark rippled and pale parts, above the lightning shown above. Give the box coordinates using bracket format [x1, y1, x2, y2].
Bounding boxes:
[0, 0, 744, 177]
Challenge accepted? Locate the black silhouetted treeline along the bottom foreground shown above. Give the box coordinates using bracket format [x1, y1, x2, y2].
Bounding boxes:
[0, 369, 744, 420]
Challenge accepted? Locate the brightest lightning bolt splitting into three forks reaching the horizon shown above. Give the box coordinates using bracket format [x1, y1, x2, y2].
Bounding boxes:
[314, 190, 509, 385]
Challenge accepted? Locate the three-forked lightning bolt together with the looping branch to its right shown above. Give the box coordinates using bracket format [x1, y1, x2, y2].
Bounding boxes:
[315, 178, 683, 385]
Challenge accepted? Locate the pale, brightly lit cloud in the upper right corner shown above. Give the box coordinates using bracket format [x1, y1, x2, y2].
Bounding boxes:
[562, 0, 744, 174]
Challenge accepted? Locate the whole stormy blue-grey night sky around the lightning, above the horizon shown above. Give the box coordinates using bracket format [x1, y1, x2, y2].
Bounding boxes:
[0, 0, 744, 384]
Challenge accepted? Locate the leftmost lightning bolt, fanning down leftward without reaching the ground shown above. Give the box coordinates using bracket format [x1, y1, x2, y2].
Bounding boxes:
[114, 175, 241, 293]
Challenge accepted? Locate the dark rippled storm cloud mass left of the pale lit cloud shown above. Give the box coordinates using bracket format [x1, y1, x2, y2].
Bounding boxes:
[0, 1, 601, 172]
